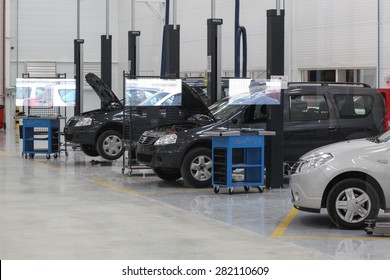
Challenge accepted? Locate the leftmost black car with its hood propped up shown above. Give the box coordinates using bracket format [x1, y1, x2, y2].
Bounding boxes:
[64, 73, 212, 160]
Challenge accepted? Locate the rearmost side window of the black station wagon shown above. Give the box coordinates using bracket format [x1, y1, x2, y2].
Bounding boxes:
[334, 94, 374, 119]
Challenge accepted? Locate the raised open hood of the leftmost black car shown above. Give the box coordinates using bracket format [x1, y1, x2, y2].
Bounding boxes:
[85, 73, 122, 108]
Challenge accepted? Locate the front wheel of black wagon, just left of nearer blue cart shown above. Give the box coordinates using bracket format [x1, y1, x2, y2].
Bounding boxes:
[181, 147, 212, 188]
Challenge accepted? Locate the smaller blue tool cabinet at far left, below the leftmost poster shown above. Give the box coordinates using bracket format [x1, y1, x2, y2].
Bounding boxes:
[22, 118, 60, 159]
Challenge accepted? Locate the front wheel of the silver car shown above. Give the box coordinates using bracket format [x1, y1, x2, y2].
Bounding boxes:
[327, 178, 379, 229]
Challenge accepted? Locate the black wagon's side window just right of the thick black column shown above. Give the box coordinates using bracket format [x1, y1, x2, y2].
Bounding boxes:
[289, 95, 329, 121]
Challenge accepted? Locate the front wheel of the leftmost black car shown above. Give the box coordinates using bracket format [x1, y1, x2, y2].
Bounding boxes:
[96, 130, 123, 160]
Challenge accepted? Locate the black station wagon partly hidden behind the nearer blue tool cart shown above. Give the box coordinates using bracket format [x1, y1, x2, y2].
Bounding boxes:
[136, 83, 387, 187]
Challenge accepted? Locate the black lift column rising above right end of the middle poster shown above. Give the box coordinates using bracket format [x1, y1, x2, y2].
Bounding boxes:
[164, 24, 180, 78]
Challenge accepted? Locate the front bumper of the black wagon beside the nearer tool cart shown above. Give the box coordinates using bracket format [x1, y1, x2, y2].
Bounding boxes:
[136, 144, 184, 168]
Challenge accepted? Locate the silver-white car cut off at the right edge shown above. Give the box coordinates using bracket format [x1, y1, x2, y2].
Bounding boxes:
[290, 131, 390, 229]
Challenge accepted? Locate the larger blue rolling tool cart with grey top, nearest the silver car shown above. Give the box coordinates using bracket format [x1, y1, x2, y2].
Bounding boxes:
[203, 129, 275, 194]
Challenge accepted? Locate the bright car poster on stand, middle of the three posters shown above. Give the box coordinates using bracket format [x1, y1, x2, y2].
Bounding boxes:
[125, 78, 182, 106]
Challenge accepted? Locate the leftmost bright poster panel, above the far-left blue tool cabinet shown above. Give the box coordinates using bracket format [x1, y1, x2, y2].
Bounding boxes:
[16, 78, 76, 107]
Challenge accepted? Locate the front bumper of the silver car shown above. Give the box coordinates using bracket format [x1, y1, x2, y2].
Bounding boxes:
[289, 168, 329, 212]
